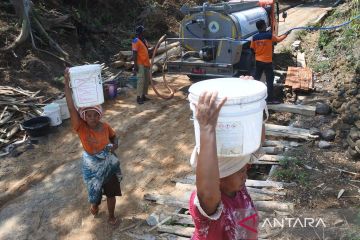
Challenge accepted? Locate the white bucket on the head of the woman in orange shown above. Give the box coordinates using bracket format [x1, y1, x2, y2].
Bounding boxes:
[69, 64, 104, 107]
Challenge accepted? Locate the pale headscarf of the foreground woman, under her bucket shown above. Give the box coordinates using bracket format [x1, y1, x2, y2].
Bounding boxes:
[190, 147, 251, 178]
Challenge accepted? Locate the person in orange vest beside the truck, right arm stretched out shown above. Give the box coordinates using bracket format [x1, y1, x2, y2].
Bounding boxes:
[250, 20, 289, 104]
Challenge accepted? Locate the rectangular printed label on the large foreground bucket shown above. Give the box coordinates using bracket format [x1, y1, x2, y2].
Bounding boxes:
[216, 121, 244, 157]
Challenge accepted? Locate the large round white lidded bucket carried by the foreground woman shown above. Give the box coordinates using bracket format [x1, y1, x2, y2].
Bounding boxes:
[189, 78, 267, 158]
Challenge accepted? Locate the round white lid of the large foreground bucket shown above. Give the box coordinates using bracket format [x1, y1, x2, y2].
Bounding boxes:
[189, 78, 267, 105]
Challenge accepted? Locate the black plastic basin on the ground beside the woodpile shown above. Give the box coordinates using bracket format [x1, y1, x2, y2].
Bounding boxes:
[22, 117, 50, 137]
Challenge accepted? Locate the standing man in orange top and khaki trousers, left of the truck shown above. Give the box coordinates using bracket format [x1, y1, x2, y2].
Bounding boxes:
[132, 25, 150, 104]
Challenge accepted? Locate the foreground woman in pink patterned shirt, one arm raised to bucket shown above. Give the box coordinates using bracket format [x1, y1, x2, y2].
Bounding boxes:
[189, 77, 264, 240]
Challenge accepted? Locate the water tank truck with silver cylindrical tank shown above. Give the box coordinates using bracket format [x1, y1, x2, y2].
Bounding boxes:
[167, 0, 286, 79]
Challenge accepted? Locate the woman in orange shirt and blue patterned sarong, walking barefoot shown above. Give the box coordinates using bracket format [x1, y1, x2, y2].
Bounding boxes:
[64, 68, 122, 225]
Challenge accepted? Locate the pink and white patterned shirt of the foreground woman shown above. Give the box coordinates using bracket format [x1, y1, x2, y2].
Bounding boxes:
[189, 187, 259, 240]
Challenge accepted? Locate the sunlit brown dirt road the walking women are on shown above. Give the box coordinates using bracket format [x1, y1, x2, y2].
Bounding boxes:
[0, 0, 340, 240]
